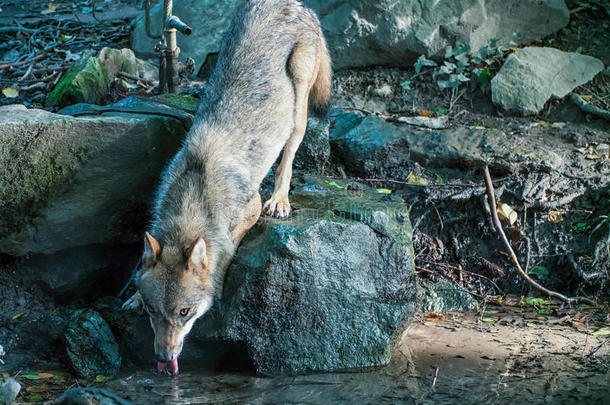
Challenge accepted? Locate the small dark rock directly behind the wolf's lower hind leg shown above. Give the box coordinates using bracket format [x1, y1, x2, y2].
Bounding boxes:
[294, 117, 330, 172]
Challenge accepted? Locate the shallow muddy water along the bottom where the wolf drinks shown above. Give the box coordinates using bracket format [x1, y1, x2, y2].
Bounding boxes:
[102, 317, 610, 404]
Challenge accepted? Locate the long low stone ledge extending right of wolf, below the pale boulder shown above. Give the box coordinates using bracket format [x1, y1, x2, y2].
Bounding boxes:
[330, 112, 570, 177]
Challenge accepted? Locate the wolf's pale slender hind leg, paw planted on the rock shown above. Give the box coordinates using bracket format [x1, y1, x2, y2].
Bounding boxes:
[263, 42, 319, 218]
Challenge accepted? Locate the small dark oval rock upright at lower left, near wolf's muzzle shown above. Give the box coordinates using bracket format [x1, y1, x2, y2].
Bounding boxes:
[64, 309, 121, 377]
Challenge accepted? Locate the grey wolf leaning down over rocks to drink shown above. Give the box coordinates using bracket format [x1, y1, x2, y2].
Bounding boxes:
[123, 0, 331, 373]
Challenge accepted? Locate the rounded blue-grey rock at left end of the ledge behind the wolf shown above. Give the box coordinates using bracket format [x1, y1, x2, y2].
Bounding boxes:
[330, 113, 409, 178]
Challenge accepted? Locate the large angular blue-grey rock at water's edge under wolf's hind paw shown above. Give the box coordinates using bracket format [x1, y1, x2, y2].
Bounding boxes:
[195, 177, 419, 375]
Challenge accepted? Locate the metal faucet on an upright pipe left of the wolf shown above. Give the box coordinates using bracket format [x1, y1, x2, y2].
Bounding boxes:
[144, 0, 193, 93]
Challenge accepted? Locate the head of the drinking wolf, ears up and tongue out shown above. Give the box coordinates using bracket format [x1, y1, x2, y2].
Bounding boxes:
[123, 232, 214, 373]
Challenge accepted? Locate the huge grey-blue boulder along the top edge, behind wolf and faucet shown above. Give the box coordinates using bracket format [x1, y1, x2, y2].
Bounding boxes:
[132, 0, 570, 70]
